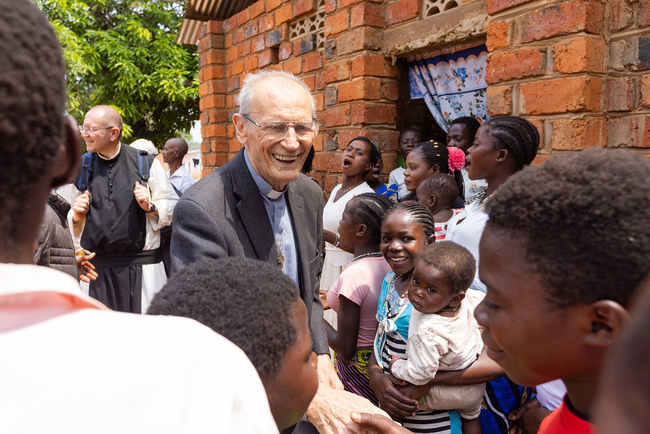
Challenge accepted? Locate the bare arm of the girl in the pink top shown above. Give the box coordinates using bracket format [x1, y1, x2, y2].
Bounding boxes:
[323, 295, 361, 360]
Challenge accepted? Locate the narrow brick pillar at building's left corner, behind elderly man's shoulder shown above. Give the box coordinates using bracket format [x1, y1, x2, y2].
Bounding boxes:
[198, 21, 229, 176]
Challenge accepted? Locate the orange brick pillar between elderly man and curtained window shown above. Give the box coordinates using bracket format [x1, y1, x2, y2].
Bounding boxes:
[314, 0, 397, 193]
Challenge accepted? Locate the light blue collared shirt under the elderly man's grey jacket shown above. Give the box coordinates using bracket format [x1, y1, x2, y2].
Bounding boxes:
[244, 150, 300, 288]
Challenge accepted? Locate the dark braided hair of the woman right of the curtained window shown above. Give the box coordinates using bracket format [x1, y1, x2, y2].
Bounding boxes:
[482, 116, 539, 170]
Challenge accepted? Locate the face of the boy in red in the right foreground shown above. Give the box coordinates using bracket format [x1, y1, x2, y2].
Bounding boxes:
[474, 222, 589, 386]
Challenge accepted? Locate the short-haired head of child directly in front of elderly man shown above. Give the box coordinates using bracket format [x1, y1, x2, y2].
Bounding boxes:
[147, 258, 318, 430]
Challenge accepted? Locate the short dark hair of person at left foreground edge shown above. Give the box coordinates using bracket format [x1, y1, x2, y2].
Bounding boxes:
[0, 0, 66, 249]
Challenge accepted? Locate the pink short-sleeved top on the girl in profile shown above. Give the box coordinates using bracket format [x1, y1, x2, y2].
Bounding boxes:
[327, 256, 391, 347]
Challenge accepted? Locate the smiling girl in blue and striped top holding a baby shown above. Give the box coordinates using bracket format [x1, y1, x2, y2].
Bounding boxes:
[370, 201, 457, 433]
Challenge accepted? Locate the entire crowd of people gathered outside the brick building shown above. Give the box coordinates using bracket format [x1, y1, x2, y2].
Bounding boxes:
[0, 0, 650, 434]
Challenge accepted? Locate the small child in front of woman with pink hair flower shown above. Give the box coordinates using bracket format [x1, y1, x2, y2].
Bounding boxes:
[415, 173, 463, 241]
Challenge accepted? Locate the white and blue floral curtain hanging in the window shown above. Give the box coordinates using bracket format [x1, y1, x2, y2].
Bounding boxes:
[408, 45, 489, 131]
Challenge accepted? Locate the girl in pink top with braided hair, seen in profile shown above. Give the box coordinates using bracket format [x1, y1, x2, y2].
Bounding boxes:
[323, 193, 393, 405]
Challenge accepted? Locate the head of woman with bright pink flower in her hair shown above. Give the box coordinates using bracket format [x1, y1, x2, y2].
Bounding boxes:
[404, 140, 465, 208]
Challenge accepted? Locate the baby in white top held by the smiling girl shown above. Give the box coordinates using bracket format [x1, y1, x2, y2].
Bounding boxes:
[389, 241, 485, 433]
